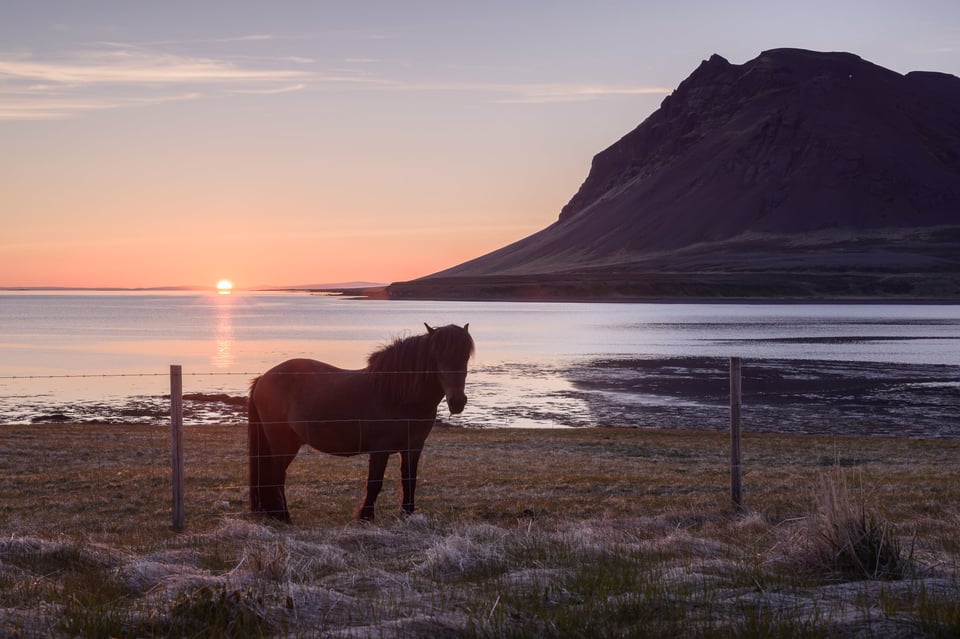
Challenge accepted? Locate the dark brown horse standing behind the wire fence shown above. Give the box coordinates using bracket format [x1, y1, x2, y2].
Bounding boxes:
[248, 324, 474, 521]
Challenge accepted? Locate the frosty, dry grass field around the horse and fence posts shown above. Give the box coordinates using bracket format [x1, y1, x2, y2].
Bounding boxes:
[0, 425, 960, 637]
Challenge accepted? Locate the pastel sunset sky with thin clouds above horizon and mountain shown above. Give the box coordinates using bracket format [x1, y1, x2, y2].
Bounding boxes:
[0, 0, 960, 287]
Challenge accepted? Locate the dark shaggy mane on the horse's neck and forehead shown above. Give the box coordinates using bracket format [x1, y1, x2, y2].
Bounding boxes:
[367, 327, 474, 403]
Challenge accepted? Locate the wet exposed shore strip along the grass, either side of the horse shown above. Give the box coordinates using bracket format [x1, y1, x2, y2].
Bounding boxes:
[9, 357, 960, 439]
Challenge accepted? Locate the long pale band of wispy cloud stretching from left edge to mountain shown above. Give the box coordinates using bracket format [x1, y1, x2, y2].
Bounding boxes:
[0, 45, 671, 120]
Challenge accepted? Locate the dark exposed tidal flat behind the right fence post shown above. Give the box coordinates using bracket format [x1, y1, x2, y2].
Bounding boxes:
[569, 358, 960, 439]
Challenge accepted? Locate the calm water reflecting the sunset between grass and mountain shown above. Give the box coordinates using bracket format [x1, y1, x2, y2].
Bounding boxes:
[0, 292, 960, 436]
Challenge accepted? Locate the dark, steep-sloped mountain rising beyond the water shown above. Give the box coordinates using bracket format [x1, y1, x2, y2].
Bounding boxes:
[388, 49, 960, 298]
